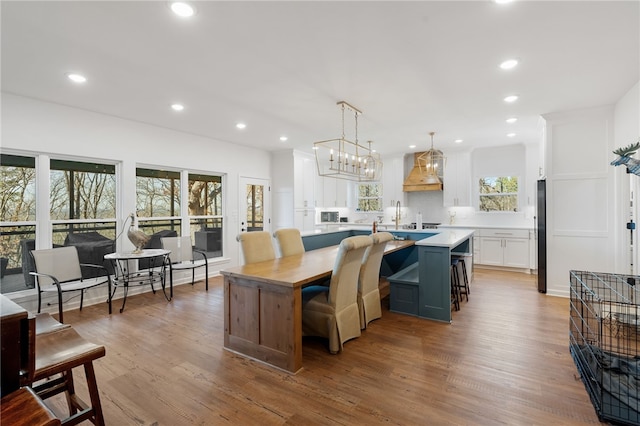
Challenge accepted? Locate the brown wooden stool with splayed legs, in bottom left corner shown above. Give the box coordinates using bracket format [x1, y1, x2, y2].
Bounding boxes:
[27, 324, 105, 425]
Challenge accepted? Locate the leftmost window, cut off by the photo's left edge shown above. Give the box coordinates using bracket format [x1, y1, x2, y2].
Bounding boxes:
[0, 154, 36, 293]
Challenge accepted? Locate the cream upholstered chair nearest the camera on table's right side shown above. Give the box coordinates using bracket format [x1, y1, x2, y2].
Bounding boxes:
[302, 235, 373, 354]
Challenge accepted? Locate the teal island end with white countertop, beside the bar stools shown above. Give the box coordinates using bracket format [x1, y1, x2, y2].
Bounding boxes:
[387, 228, 474, 322]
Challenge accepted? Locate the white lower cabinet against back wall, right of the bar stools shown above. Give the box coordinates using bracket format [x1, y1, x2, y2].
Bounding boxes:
[475, 229, 531, 269]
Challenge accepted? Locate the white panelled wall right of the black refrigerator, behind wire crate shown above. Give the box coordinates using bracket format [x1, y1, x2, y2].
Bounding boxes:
[544, 84, 640, 296]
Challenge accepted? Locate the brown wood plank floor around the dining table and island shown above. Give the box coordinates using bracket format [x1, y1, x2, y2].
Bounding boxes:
[45, 270, 600, 426]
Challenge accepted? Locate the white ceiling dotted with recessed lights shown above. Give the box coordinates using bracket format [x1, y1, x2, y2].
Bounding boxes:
[0, 0, 640, 155]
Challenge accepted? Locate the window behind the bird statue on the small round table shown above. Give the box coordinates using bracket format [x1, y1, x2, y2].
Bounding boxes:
[136, 168, 181, 235]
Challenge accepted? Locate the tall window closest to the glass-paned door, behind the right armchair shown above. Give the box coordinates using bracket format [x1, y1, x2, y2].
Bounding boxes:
[188, 173, 223, 258]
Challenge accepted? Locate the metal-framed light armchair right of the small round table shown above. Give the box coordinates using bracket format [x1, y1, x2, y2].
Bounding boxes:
[160, 236, 209, 291]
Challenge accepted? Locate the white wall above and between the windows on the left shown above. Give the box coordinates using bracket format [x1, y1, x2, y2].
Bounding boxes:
[0, 93, 271, 310]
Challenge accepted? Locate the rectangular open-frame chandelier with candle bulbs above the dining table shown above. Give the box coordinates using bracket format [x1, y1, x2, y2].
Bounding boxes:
[313, 101, 382, 182]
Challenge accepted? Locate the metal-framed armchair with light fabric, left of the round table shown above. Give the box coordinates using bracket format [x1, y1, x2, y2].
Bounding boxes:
[30, 246, 111, 322]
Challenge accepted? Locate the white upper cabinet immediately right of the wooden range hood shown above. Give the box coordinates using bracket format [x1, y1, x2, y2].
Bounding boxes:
[442, 152, 471, 207]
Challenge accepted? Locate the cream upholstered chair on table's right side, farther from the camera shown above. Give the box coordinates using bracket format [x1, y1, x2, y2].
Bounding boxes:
[358, 232, 393, 330]
